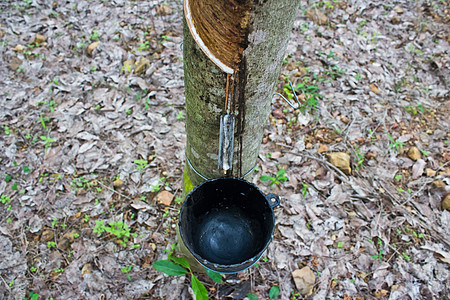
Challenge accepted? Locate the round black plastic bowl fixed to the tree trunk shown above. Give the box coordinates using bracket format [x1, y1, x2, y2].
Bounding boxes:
[178, 177, 280, 273]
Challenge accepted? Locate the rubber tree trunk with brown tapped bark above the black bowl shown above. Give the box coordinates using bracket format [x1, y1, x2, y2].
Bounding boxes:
[179, 0, 299, 270]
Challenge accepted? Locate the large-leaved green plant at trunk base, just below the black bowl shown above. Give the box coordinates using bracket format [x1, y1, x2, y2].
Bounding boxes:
[153, 244, 222, 299]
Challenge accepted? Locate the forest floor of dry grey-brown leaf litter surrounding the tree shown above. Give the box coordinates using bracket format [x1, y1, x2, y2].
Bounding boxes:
[0, 0, 450, 299]
